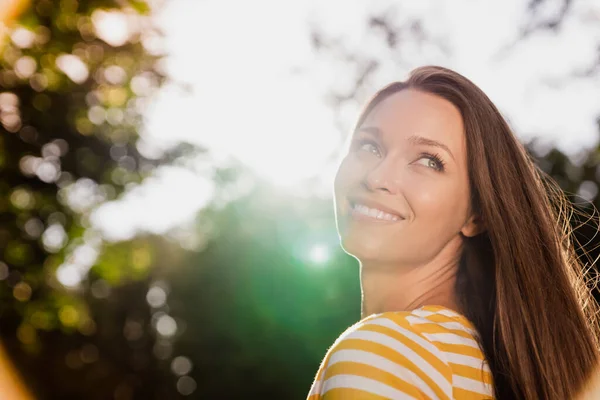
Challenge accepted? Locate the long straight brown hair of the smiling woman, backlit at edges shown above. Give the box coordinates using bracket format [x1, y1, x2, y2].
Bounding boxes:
[356, 66, 599, 400]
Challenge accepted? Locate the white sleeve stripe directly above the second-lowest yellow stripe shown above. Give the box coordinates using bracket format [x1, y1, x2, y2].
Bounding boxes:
[329, 350, 437, 398]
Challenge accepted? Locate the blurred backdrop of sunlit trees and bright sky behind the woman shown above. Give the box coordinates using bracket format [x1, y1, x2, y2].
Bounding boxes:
[0, 0, 600, 400]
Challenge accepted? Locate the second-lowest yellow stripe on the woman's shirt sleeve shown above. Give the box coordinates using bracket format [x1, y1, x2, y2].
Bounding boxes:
[325, 361, 427, 398]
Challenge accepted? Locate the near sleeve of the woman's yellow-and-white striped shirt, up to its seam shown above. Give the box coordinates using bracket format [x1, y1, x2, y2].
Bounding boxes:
[308, 313, 452, 400]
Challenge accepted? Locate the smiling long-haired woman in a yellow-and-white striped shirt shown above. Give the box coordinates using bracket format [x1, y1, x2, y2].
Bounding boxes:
[309, 66, 599, 400]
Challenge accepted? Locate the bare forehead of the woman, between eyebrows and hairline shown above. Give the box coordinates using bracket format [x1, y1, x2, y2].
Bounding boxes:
[362, 89, 465, 151]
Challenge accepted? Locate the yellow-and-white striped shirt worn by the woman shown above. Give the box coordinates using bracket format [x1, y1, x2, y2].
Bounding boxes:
[307, 305, 494, 400]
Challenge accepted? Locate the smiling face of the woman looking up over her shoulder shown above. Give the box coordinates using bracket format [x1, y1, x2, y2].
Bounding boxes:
[335, 89, 471, 266]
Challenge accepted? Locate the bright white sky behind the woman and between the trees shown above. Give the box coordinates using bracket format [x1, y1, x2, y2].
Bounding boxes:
[93, 0, 600, 240]
